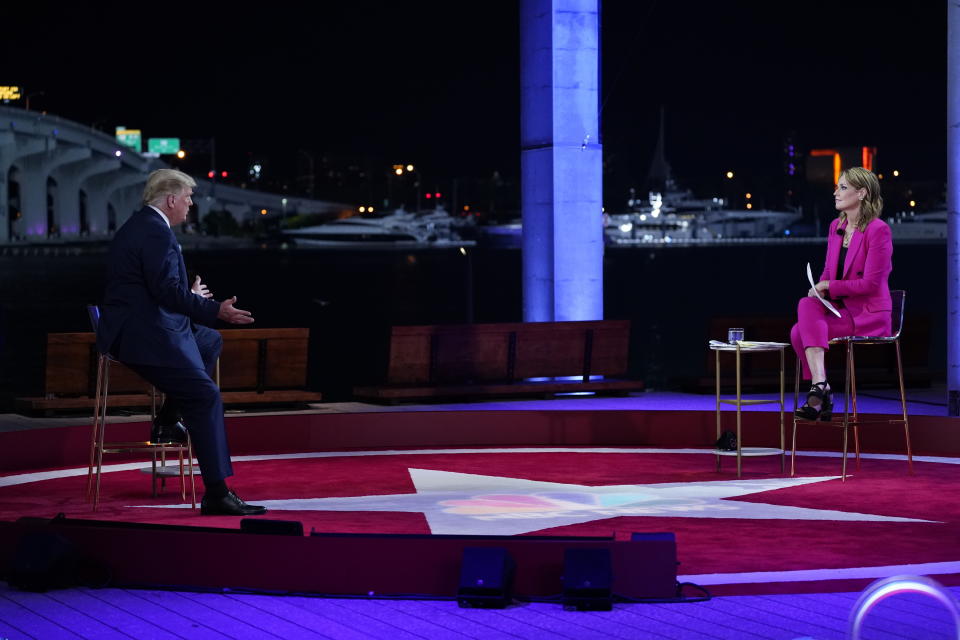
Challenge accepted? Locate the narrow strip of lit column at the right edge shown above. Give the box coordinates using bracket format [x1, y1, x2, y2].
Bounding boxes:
[947, 2, 960, 416]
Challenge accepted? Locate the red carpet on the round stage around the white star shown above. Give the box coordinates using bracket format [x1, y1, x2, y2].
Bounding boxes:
[0, 452, 960, 592]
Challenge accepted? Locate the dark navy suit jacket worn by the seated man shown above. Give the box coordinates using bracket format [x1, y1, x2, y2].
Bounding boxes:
[97, 207, 220, 369]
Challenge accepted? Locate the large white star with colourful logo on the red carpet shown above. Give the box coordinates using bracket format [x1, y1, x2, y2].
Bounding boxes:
[141, 469, 930, 535]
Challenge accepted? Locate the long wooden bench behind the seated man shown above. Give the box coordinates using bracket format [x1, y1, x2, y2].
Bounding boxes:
[16, 329, 321, 411]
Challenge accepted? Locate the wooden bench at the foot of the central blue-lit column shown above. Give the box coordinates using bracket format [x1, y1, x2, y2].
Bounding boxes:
[354, 320, 643, 401]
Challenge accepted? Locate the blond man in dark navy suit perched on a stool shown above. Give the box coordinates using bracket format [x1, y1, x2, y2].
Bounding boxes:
[97, 169, 266, 516]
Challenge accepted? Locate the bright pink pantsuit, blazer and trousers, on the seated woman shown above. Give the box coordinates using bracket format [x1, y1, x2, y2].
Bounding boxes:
[790, 218, 893, 382]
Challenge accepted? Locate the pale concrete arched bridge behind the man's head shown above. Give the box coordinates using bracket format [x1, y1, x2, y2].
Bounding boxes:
[0, 106, 353, 243]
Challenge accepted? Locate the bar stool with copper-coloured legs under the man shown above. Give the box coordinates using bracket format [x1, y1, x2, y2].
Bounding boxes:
[86, 305, 197, 511]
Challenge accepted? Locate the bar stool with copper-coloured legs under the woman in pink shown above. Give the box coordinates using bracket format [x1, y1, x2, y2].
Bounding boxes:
[790, 290, 913, 481]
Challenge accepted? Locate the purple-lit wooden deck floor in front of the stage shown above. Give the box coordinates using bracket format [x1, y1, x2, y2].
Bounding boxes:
[0, 583, 960, 640]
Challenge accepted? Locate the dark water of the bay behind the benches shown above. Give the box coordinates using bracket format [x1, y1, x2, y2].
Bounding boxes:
[0, 244, 946, 411]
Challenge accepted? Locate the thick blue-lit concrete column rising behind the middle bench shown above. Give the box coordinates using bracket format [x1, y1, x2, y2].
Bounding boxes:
[520, 0, 603, 322]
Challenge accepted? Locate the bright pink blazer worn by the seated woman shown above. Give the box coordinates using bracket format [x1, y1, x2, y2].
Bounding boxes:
[820, 218, 893, 336]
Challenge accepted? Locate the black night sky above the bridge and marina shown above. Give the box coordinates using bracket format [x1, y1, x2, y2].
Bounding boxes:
[0, 0, 946, 208]
